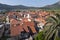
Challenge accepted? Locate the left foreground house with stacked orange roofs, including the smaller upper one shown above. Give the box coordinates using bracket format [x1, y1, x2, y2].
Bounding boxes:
[10, 19, 23, 36]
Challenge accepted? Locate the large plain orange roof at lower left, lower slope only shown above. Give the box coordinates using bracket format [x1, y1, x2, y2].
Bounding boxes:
[10, 25, 24, 36]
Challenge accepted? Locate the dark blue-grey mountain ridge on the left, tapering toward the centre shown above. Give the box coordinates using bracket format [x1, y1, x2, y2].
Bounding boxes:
[0, 3, 38, 10]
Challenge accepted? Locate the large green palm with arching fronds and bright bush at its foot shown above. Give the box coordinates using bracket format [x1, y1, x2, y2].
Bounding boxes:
[35, 14, 60, 40]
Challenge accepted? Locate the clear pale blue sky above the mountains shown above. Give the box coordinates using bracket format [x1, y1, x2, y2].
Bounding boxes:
[0, 0, 59, 7]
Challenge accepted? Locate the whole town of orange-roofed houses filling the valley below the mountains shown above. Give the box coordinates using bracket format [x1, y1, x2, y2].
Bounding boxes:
[0, 10, 50, 40]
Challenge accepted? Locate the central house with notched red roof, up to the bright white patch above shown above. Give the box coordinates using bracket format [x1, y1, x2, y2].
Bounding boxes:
[22, 18, 37, 33]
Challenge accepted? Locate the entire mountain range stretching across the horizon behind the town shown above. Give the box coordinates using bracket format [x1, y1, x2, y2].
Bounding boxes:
[0, 1, 60, 11]
